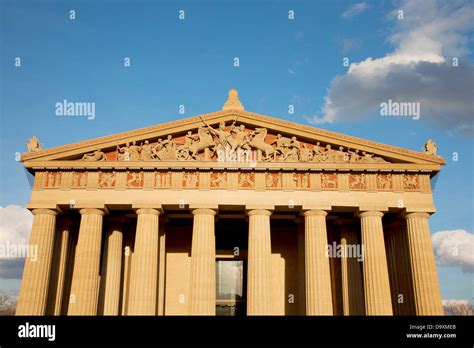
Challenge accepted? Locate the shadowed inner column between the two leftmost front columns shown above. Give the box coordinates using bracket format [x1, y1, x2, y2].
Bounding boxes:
[47, 218, 73, 315]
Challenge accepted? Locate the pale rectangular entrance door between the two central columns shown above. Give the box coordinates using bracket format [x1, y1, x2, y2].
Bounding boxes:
[216, 260, 247, 316]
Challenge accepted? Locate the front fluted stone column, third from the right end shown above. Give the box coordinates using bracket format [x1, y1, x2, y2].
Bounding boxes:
[303, 210, 333, 315]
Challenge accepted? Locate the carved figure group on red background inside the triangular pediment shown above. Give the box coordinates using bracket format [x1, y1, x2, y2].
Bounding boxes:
[76, 122, 386, 163]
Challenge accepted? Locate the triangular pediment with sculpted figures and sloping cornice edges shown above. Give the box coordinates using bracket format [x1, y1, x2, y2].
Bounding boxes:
[21, 109, 444, 170]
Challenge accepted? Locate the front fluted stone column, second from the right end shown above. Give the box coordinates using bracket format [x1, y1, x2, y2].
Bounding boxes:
[359, 211, 393, 315]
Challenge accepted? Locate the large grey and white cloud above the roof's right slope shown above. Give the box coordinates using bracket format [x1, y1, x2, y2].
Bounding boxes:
[311, 0, 474, 135]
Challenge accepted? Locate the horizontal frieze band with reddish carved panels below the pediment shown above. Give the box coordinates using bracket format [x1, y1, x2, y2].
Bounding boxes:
[34, 170, 431, 193]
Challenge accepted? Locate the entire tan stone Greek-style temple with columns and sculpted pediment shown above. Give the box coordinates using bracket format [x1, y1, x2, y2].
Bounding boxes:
[17, 89, 445, 315]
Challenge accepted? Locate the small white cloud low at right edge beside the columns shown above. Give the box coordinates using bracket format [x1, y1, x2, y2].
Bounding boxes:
[431, 230, 474, 273]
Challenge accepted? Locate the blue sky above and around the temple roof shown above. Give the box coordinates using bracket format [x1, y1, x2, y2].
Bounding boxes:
[0, 0, 474, 302]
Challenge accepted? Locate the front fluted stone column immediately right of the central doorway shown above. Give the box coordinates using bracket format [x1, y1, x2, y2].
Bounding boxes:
[247, 209, 272, 315]
